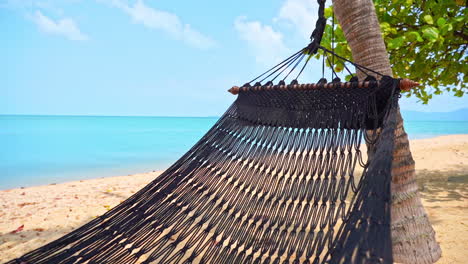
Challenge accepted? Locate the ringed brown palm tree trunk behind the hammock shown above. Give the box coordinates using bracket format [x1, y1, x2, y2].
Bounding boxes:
[333, 0, 441, 264]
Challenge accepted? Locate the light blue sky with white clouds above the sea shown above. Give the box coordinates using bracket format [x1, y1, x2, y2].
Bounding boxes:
[0, 0, 468, 116]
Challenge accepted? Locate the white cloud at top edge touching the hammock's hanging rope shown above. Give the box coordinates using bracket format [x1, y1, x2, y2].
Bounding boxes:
[276, 0, 318, 39]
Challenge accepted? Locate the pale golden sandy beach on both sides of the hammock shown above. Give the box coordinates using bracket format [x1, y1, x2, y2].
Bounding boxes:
[0, 135, 468, 264]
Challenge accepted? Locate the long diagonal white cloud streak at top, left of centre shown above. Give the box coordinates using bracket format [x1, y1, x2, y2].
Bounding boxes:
[105, 0, 215, 49]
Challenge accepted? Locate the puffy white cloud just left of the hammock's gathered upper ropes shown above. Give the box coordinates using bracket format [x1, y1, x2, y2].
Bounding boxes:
[234, 16, 289, 66]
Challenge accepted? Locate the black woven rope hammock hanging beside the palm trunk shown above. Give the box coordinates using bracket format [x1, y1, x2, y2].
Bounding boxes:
[7, 0, 420, 264]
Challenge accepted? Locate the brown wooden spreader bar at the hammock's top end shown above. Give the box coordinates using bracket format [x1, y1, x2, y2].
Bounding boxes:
[228, 79, 419, 95]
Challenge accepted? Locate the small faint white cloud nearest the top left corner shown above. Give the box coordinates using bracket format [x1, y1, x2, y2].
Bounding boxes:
[33, 11, 88, 40]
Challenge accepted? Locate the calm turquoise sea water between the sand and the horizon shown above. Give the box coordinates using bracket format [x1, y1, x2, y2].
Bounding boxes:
[0, 116, 468, 190]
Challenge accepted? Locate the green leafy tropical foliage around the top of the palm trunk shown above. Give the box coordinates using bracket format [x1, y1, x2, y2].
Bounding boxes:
[322, 0, 468, 103]
